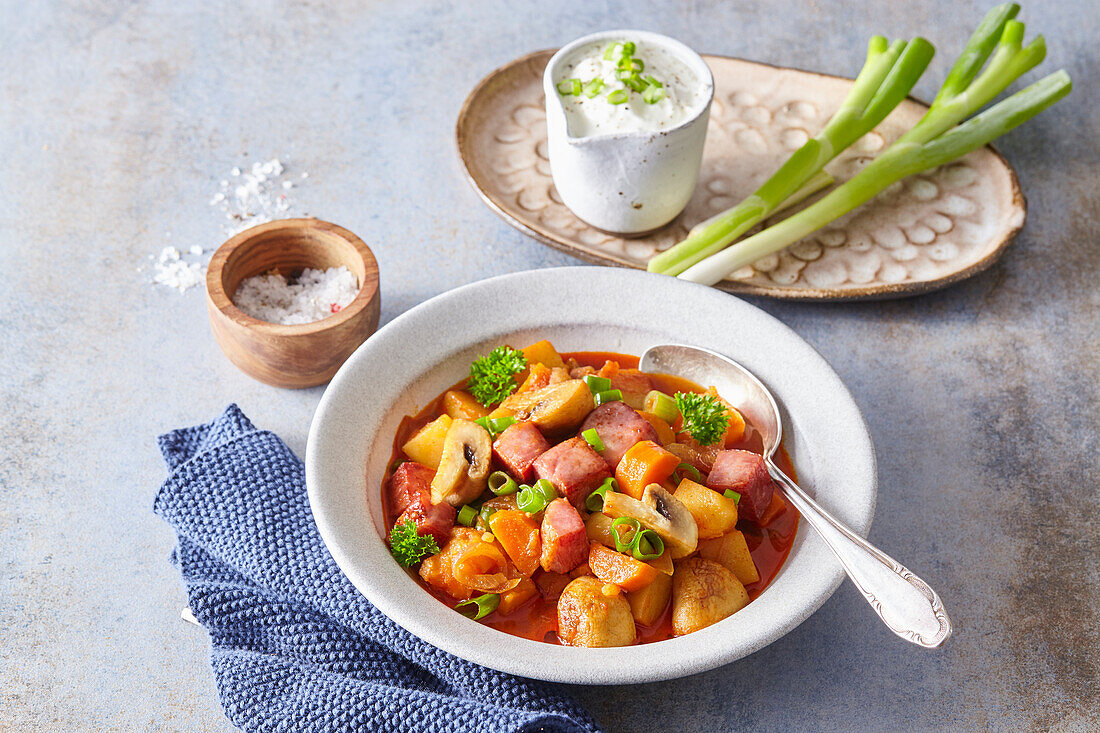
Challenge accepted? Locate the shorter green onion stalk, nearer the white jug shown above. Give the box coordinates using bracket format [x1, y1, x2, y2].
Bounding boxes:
[649, 35, 935, 275]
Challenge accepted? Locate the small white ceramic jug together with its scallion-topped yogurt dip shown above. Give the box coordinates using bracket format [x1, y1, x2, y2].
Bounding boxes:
[542, 30, 714, 231]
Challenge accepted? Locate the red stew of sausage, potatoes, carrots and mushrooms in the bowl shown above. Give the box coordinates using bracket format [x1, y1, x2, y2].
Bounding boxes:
[382, 341, 799, 646]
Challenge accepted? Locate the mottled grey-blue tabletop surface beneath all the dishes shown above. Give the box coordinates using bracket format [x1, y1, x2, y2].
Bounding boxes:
[0, 0, 1100, 731]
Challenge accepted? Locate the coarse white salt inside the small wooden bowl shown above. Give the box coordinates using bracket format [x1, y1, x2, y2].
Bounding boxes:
[233, 266, 359, 326]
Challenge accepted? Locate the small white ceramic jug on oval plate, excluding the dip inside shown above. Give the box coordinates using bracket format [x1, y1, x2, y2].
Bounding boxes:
[542, 31, 714, 236]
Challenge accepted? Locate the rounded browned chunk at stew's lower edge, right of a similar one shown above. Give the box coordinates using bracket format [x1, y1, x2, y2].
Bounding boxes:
[672, 557, 749, 636]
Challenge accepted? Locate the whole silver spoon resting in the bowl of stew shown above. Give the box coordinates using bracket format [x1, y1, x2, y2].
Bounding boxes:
[640, 344, 952, 648]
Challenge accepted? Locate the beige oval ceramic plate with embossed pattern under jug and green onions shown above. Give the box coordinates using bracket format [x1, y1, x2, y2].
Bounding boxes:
[455, 51, 1026, 299]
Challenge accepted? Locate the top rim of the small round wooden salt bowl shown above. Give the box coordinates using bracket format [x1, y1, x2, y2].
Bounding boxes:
[206, 217, 378, 337]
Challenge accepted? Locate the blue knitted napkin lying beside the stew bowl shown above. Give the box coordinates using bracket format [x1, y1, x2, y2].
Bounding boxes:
[154, 405, 598, 733]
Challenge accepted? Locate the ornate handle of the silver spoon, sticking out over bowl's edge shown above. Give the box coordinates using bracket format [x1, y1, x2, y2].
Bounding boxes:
[768, 460, 952, 648]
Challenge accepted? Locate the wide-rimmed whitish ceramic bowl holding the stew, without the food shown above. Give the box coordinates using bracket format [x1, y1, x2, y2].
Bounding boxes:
[306, 267, 876, 685]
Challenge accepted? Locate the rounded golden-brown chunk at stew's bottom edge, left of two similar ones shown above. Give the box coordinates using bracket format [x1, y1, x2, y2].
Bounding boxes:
[558, 576, 636, 646]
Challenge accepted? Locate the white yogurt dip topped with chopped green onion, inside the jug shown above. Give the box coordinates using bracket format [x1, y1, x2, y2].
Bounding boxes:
[554, 37, 707, 138]
